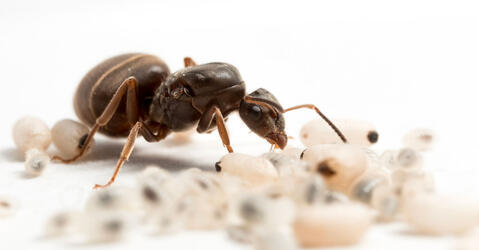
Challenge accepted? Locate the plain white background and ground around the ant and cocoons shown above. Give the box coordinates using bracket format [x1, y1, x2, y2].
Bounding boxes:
[0, 1, 479, 249]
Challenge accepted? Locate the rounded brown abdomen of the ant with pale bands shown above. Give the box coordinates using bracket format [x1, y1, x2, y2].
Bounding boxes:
[74, 53, 170, 137]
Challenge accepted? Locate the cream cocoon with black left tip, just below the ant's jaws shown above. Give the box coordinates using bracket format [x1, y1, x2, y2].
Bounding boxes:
[215, 153, 278, 184]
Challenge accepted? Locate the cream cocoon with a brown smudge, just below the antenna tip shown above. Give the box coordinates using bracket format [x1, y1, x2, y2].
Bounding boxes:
[303, 145, 368, 193]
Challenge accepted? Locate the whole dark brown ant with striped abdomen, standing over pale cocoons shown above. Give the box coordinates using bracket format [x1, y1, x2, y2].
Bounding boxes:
[53, 53, 346, 187]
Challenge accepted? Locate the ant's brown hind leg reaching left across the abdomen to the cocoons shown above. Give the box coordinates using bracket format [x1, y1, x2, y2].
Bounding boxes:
[52, 77, 138, 163]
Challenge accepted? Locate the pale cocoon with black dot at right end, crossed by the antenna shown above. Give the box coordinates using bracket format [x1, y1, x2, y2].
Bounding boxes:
[300, 119, 379, 147]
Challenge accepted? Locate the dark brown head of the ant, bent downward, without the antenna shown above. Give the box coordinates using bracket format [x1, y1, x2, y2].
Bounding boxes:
[239, 88, 288, 149]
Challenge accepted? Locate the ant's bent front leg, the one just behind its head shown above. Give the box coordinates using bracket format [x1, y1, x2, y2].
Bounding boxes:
[196, 106, 233, 153]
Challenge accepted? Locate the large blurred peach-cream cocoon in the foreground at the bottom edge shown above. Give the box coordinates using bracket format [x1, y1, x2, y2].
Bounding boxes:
[293, 203, 372, 248]
